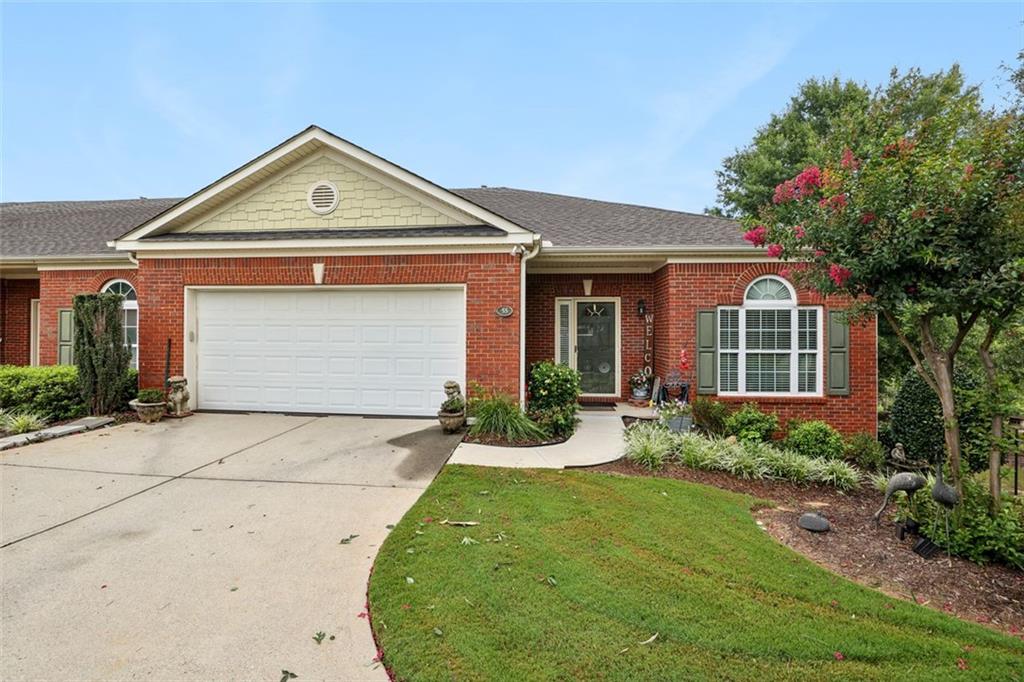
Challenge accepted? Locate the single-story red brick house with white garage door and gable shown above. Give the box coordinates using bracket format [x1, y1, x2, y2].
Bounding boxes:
[0, 126, 877, 432]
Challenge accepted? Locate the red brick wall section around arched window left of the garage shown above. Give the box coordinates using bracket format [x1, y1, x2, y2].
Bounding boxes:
[39, 268, 145, 365]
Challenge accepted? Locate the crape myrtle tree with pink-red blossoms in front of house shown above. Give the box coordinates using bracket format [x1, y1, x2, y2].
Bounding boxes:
[745, 69, 1024, 489]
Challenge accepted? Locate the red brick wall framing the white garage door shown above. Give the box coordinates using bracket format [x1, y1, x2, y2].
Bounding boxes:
[138, 253, 519, 397]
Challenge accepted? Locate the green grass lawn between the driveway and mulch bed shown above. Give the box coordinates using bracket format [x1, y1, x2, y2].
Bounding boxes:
[370, 466, 1024, 681]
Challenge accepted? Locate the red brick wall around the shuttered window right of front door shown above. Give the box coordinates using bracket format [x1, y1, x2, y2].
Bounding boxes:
[653, 263, 878, 434]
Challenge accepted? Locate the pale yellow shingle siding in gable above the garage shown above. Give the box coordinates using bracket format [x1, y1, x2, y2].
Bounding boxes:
[184, 157, 471, 232]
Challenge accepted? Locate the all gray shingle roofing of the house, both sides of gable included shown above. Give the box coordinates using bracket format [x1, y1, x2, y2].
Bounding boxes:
[0, 187, 748, 259]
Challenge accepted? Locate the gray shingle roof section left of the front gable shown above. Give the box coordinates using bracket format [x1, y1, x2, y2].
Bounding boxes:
[0, 199, 181, 258]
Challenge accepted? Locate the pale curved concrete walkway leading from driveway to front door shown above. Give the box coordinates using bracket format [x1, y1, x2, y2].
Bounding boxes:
[449, 406, 650, 469]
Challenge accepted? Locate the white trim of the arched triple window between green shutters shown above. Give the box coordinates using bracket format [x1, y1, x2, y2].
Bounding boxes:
[715, 278, 824, 398]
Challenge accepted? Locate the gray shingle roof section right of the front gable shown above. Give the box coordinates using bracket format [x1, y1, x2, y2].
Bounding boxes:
[452, 187, 749, 247]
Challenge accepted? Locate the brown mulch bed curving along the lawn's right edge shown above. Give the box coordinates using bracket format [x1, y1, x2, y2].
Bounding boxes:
[591, 460, 1024, 640]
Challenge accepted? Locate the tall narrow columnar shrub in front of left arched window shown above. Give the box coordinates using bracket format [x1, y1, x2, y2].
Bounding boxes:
[75, 294, 131, 415]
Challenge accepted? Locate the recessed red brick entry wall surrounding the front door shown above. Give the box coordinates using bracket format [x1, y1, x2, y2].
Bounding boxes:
[526, 273, 657, 398]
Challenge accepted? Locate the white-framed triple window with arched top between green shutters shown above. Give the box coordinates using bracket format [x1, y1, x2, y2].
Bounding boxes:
[718, 276, 821, 395]
